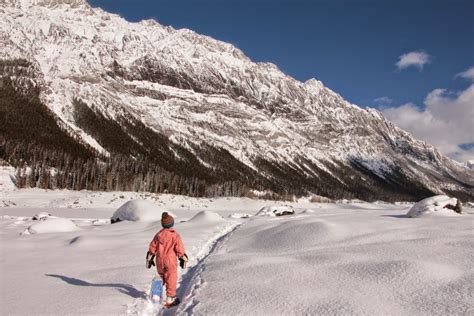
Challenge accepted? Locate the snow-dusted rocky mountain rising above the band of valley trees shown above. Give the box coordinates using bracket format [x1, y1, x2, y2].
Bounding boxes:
[0, 0, 474, 200]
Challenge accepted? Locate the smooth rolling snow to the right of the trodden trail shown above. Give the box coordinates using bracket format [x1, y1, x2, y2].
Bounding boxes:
[186, 207, 474, 315]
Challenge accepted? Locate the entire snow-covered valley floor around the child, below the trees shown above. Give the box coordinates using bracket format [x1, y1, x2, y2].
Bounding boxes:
[0, 188, 474, 315]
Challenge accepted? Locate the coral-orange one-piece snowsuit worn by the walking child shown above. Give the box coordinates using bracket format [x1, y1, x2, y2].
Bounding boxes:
[149, 228, 184, 297]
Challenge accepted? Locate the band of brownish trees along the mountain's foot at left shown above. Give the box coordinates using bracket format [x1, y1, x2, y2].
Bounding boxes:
[5, 142, 249, 197]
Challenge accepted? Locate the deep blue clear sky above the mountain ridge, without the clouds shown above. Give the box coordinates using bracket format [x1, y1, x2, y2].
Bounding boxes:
[90, 0, 474, 160]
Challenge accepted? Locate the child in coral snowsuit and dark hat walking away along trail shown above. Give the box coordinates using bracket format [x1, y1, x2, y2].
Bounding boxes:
[146, 212, 188, 306]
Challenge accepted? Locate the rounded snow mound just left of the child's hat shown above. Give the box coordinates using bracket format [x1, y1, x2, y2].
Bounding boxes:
[111, 200, 163, 223]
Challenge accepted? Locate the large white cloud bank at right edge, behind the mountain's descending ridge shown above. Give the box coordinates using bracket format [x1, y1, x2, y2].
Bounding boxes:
[382, 84, 474, 161]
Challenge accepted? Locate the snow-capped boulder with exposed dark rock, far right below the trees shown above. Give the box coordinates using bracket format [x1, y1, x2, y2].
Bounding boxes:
[407, 195, 458, 217]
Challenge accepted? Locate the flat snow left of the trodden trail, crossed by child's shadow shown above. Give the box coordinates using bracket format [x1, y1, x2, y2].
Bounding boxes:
[0, 190, 246, 315]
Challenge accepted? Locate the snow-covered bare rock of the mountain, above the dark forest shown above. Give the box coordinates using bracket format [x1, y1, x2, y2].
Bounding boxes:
[0, 0, 470, 200]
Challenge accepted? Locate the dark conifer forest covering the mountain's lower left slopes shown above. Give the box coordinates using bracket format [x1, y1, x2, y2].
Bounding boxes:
[0, 60, 264, 197]
